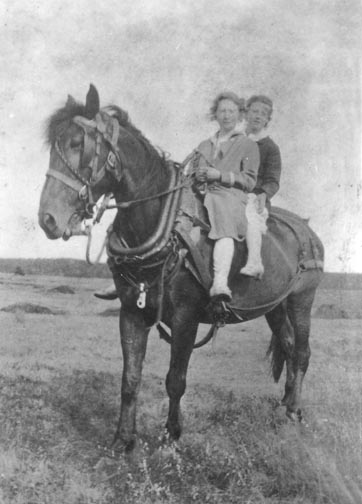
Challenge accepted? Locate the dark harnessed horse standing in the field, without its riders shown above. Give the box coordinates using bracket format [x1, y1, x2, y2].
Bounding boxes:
[39, 85, 323, 449]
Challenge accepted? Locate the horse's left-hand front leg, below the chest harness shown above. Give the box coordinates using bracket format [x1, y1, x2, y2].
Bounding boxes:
[112, 308, 150, 451]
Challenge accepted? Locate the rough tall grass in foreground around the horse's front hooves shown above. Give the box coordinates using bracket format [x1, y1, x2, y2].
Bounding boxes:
[0, 372, 362, 504]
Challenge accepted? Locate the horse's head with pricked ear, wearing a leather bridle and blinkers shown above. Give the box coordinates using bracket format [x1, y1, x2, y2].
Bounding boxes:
[39, 85, 120, 239]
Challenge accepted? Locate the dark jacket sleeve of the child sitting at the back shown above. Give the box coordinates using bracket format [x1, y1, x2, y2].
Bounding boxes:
[253, 137, 282, 199]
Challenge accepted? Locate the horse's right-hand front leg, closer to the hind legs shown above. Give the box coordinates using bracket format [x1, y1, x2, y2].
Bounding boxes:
[166, 310, 198, 439]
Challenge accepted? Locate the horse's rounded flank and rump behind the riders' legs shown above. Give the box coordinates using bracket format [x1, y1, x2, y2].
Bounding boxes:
[230, 204, 324, 316]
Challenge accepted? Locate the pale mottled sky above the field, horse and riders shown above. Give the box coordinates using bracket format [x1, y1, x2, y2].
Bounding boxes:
[0, 0, 362, 273]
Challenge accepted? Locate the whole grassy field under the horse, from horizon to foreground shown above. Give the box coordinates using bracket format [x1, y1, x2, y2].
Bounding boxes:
[0, 273, 362, 504]
